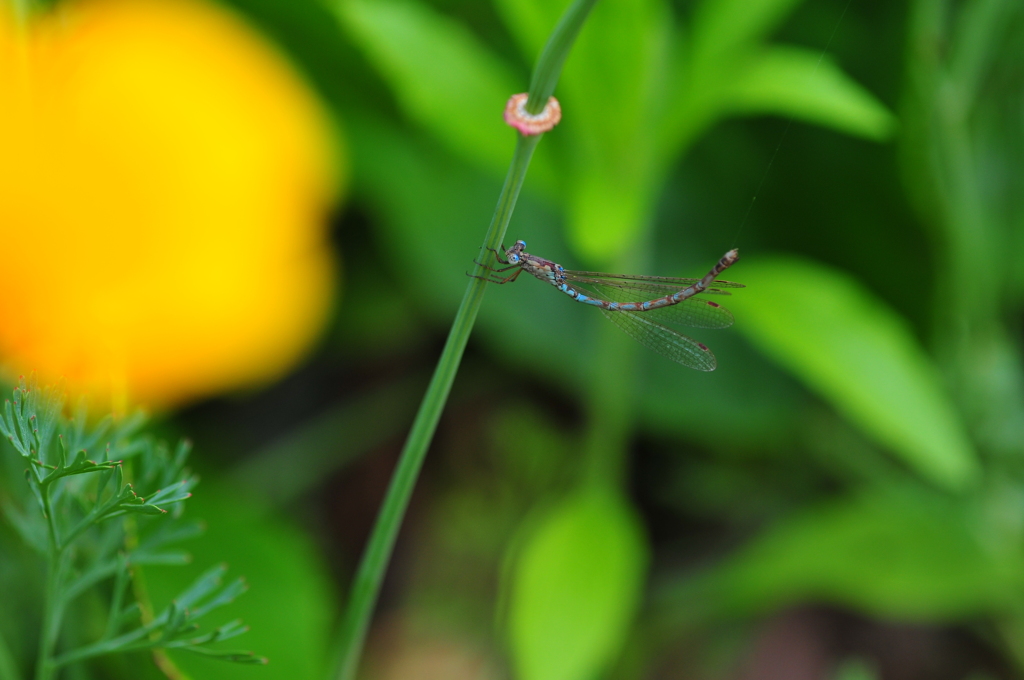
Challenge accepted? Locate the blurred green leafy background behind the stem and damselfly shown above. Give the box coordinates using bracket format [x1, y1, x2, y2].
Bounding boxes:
[0, 0, 1024, 680]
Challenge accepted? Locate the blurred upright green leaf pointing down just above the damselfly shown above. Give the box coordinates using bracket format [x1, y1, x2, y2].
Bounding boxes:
[557, 0, 673, 267]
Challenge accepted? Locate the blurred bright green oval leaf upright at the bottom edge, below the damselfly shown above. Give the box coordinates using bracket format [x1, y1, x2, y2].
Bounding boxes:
[509, 490, 647, 680]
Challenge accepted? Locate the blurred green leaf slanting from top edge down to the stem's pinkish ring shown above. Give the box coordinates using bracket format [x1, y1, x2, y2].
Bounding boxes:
[333, 0, 516, 172]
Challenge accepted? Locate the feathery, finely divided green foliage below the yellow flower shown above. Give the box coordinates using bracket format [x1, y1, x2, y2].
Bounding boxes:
[0, 380, 266, 680]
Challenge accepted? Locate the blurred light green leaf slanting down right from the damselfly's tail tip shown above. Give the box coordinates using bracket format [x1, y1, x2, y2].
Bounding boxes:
[728, 257, 979, 488]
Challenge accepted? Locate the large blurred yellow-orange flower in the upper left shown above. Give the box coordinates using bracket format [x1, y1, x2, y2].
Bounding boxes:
[0, 0, 340, 408]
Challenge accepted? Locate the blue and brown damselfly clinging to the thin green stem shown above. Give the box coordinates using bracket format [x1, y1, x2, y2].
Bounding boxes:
[477, 241, 743, 371]
